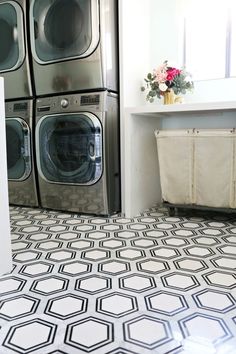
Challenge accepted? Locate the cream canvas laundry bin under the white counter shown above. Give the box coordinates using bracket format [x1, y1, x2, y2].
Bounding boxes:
[155, 129, 236, 208]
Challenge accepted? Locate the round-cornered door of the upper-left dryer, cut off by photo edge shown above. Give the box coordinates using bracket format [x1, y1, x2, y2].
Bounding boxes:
[0, 1, 25, 72]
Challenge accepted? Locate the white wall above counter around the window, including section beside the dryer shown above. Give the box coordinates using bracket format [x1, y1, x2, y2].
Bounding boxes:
[120, 0, 236, 107]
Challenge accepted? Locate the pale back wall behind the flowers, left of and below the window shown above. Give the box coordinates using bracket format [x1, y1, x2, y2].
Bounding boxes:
[150, 0, 236, 103]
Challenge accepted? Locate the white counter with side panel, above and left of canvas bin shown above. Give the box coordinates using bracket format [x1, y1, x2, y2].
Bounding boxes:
[121, 101, 236, 217]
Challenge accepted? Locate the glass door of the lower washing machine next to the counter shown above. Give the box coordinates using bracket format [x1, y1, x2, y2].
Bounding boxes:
[36, 112, 102, 185]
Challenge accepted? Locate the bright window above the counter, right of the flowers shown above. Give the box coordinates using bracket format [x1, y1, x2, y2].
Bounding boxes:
[184, 0, 236, 80]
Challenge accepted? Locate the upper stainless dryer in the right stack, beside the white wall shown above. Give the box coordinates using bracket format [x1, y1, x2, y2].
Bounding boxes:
[30, 0, 118, 96]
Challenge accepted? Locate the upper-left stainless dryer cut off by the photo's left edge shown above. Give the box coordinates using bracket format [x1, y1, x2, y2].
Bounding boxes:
[0, 0, 32, 99]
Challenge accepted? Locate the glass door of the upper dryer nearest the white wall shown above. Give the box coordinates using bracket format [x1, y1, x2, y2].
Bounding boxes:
[30, 0, 99, 64]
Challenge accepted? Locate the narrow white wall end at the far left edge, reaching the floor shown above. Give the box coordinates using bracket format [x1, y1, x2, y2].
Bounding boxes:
[0, 77, 12, 275]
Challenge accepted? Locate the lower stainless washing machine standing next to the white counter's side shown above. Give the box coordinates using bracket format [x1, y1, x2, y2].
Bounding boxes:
[36, 91, 120, 215]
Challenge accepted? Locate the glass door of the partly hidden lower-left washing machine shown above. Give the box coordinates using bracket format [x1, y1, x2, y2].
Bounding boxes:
[6, 118, 31, 181]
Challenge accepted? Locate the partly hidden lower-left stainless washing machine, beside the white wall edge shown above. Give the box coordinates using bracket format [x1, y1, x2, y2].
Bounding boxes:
[5, 99, 38, 206]
